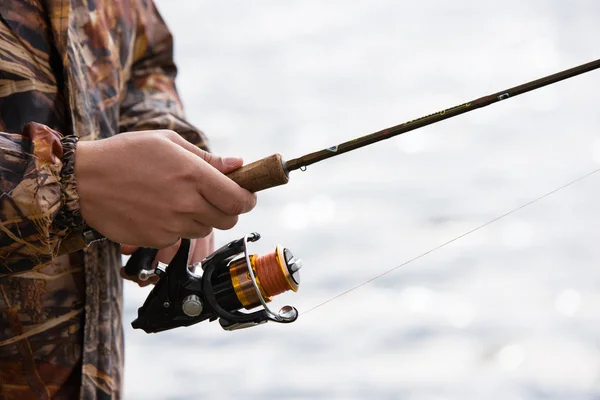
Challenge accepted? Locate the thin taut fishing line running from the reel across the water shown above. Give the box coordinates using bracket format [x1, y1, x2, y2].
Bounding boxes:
[300, 168, 600, 315]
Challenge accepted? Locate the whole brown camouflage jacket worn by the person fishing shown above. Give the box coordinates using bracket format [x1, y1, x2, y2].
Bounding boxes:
[0, 0, 205, 400]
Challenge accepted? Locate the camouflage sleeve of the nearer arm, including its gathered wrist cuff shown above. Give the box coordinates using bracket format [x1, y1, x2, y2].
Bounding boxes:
[0, 123, 85, 277]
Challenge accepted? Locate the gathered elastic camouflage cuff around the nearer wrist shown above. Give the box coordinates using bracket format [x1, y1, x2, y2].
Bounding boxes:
[56, 136, 87, 231]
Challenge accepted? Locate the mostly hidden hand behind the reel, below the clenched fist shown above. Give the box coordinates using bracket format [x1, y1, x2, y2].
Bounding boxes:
[121, 233, 214, 287]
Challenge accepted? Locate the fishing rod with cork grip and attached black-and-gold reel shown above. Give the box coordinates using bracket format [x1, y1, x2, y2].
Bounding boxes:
[120, 59, 600, 333]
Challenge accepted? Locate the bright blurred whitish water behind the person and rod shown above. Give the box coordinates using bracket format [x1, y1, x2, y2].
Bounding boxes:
[124, 0, 600, 400]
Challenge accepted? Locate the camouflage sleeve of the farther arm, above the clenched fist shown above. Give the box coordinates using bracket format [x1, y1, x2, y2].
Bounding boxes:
[119, 0, 208, 150]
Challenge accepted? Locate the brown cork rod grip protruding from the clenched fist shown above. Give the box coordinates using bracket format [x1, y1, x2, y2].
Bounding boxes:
[227, 154, 289, 193]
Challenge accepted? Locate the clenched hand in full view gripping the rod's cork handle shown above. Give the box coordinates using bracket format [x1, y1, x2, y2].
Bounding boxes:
[75, 131, 256, 249]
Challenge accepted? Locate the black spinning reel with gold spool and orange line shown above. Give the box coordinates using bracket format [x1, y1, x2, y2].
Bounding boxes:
[125, 233, 302, 333]
